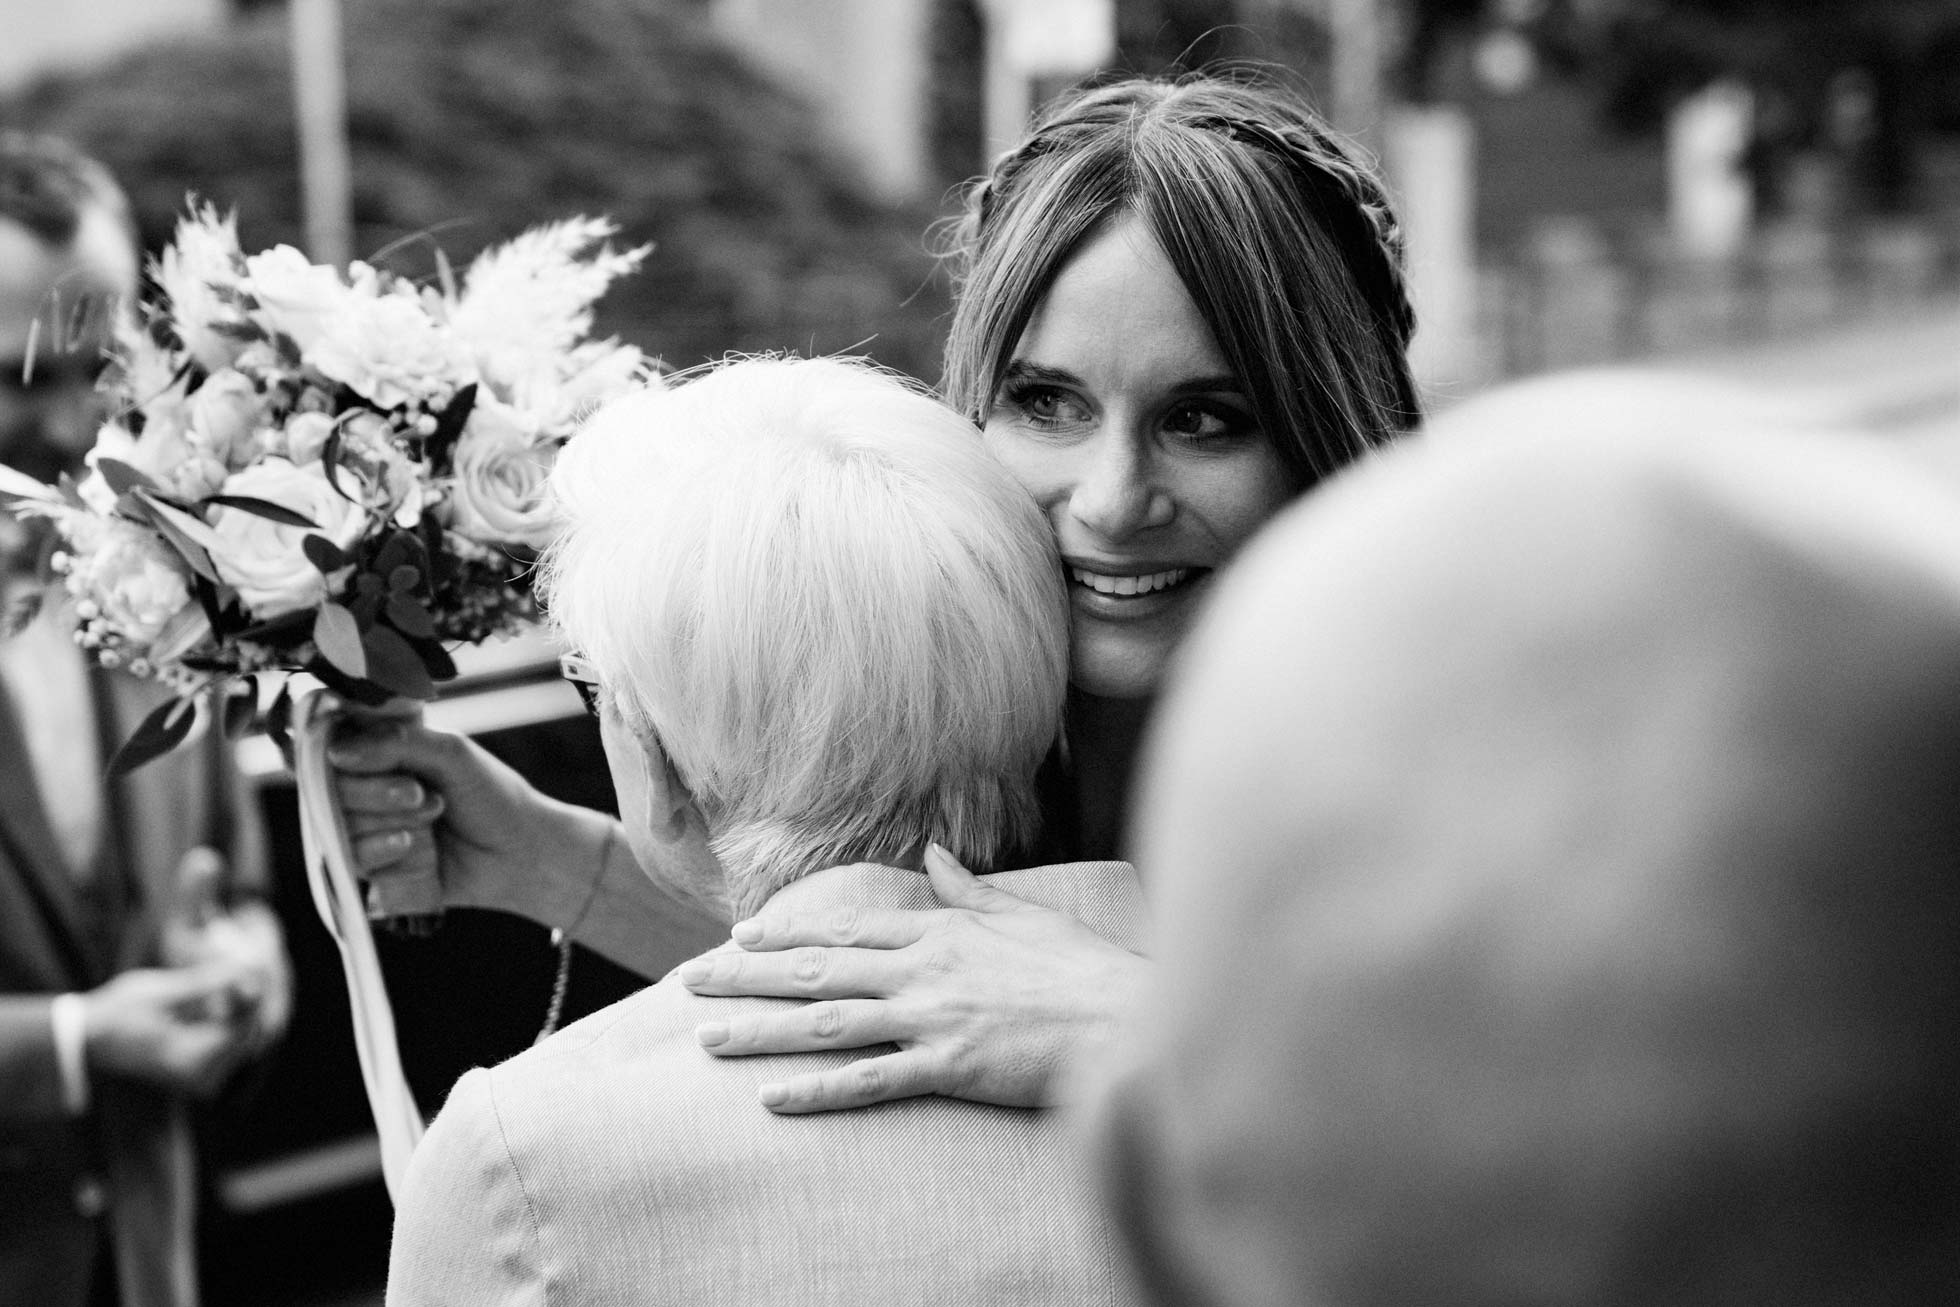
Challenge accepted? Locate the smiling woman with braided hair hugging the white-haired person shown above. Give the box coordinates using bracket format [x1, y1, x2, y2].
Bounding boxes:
[335, 74, 1417, 1111]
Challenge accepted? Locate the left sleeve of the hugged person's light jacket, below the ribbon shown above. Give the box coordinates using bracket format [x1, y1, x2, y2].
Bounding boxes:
[388, 1068, 549, 1307]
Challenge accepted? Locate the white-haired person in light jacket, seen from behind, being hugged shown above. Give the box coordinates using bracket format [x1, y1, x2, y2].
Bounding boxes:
[388, 352, 1139, 1307]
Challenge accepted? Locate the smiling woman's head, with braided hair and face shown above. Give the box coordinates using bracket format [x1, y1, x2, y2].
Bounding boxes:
[945, 76, 1417, 698]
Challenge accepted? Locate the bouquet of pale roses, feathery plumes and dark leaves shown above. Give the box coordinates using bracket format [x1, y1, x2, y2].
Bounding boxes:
[0, 208, 651, 770]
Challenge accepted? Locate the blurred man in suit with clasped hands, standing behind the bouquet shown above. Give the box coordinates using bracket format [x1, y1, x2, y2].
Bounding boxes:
[0, 133, 290, 1307]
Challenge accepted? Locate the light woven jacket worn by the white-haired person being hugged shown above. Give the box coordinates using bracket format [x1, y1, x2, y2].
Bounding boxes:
[388, 862, 1143, 1307]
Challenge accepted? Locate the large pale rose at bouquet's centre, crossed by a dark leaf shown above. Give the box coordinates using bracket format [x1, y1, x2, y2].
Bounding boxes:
[212, 459, 367, 621]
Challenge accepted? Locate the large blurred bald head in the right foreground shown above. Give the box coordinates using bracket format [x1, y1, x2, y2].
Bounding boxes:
[1100, 378, 1960, 1307]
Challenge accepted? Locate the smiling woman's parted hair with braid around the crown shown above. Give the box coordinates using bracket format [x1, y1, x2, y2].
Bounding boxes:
[943, 73, 1419, 488]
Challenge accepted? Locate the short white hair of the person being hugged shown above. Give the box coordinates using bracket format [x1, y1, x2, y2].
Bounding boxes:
[541, 357, 1068, 913]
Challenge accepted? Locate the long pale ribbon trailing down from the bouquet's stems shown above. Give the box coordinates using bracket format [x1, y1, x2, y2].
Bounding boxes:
[292, 690, 423, 1201]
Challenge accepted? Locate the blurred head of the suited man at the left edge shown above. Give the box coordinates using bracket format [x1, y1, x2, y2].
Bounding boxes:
[0, 131, 137, 480]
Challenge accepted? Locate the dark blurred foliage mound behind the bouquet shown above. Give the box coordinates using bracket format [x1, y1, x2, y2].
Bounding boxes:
[0, 0, 947, 380]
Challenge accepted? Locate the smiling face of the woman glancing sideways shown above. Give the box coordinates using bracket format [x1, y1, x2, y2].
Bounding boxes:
[986, 216, 1294, 698]
